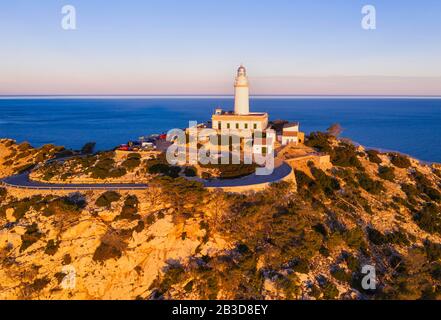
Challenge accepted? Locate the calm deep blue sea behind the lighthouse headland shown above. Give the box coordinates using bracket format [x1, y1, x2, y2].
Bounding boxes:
[0, 97, 441, 162]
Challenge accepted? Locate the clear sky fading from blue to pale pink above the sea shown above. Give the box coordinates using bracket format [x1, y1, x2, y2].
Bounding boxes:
[0, 0, 441, 95]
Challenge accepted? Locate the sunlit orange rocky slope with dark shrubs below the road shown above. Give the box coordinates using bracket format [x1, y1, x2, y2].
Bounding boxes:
[0, 133, 441, 299]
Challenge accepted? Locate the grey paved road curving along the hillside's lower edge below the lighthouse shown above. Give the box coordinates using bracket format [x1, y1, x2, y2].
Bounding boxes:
[0, 163, 292, 190]
